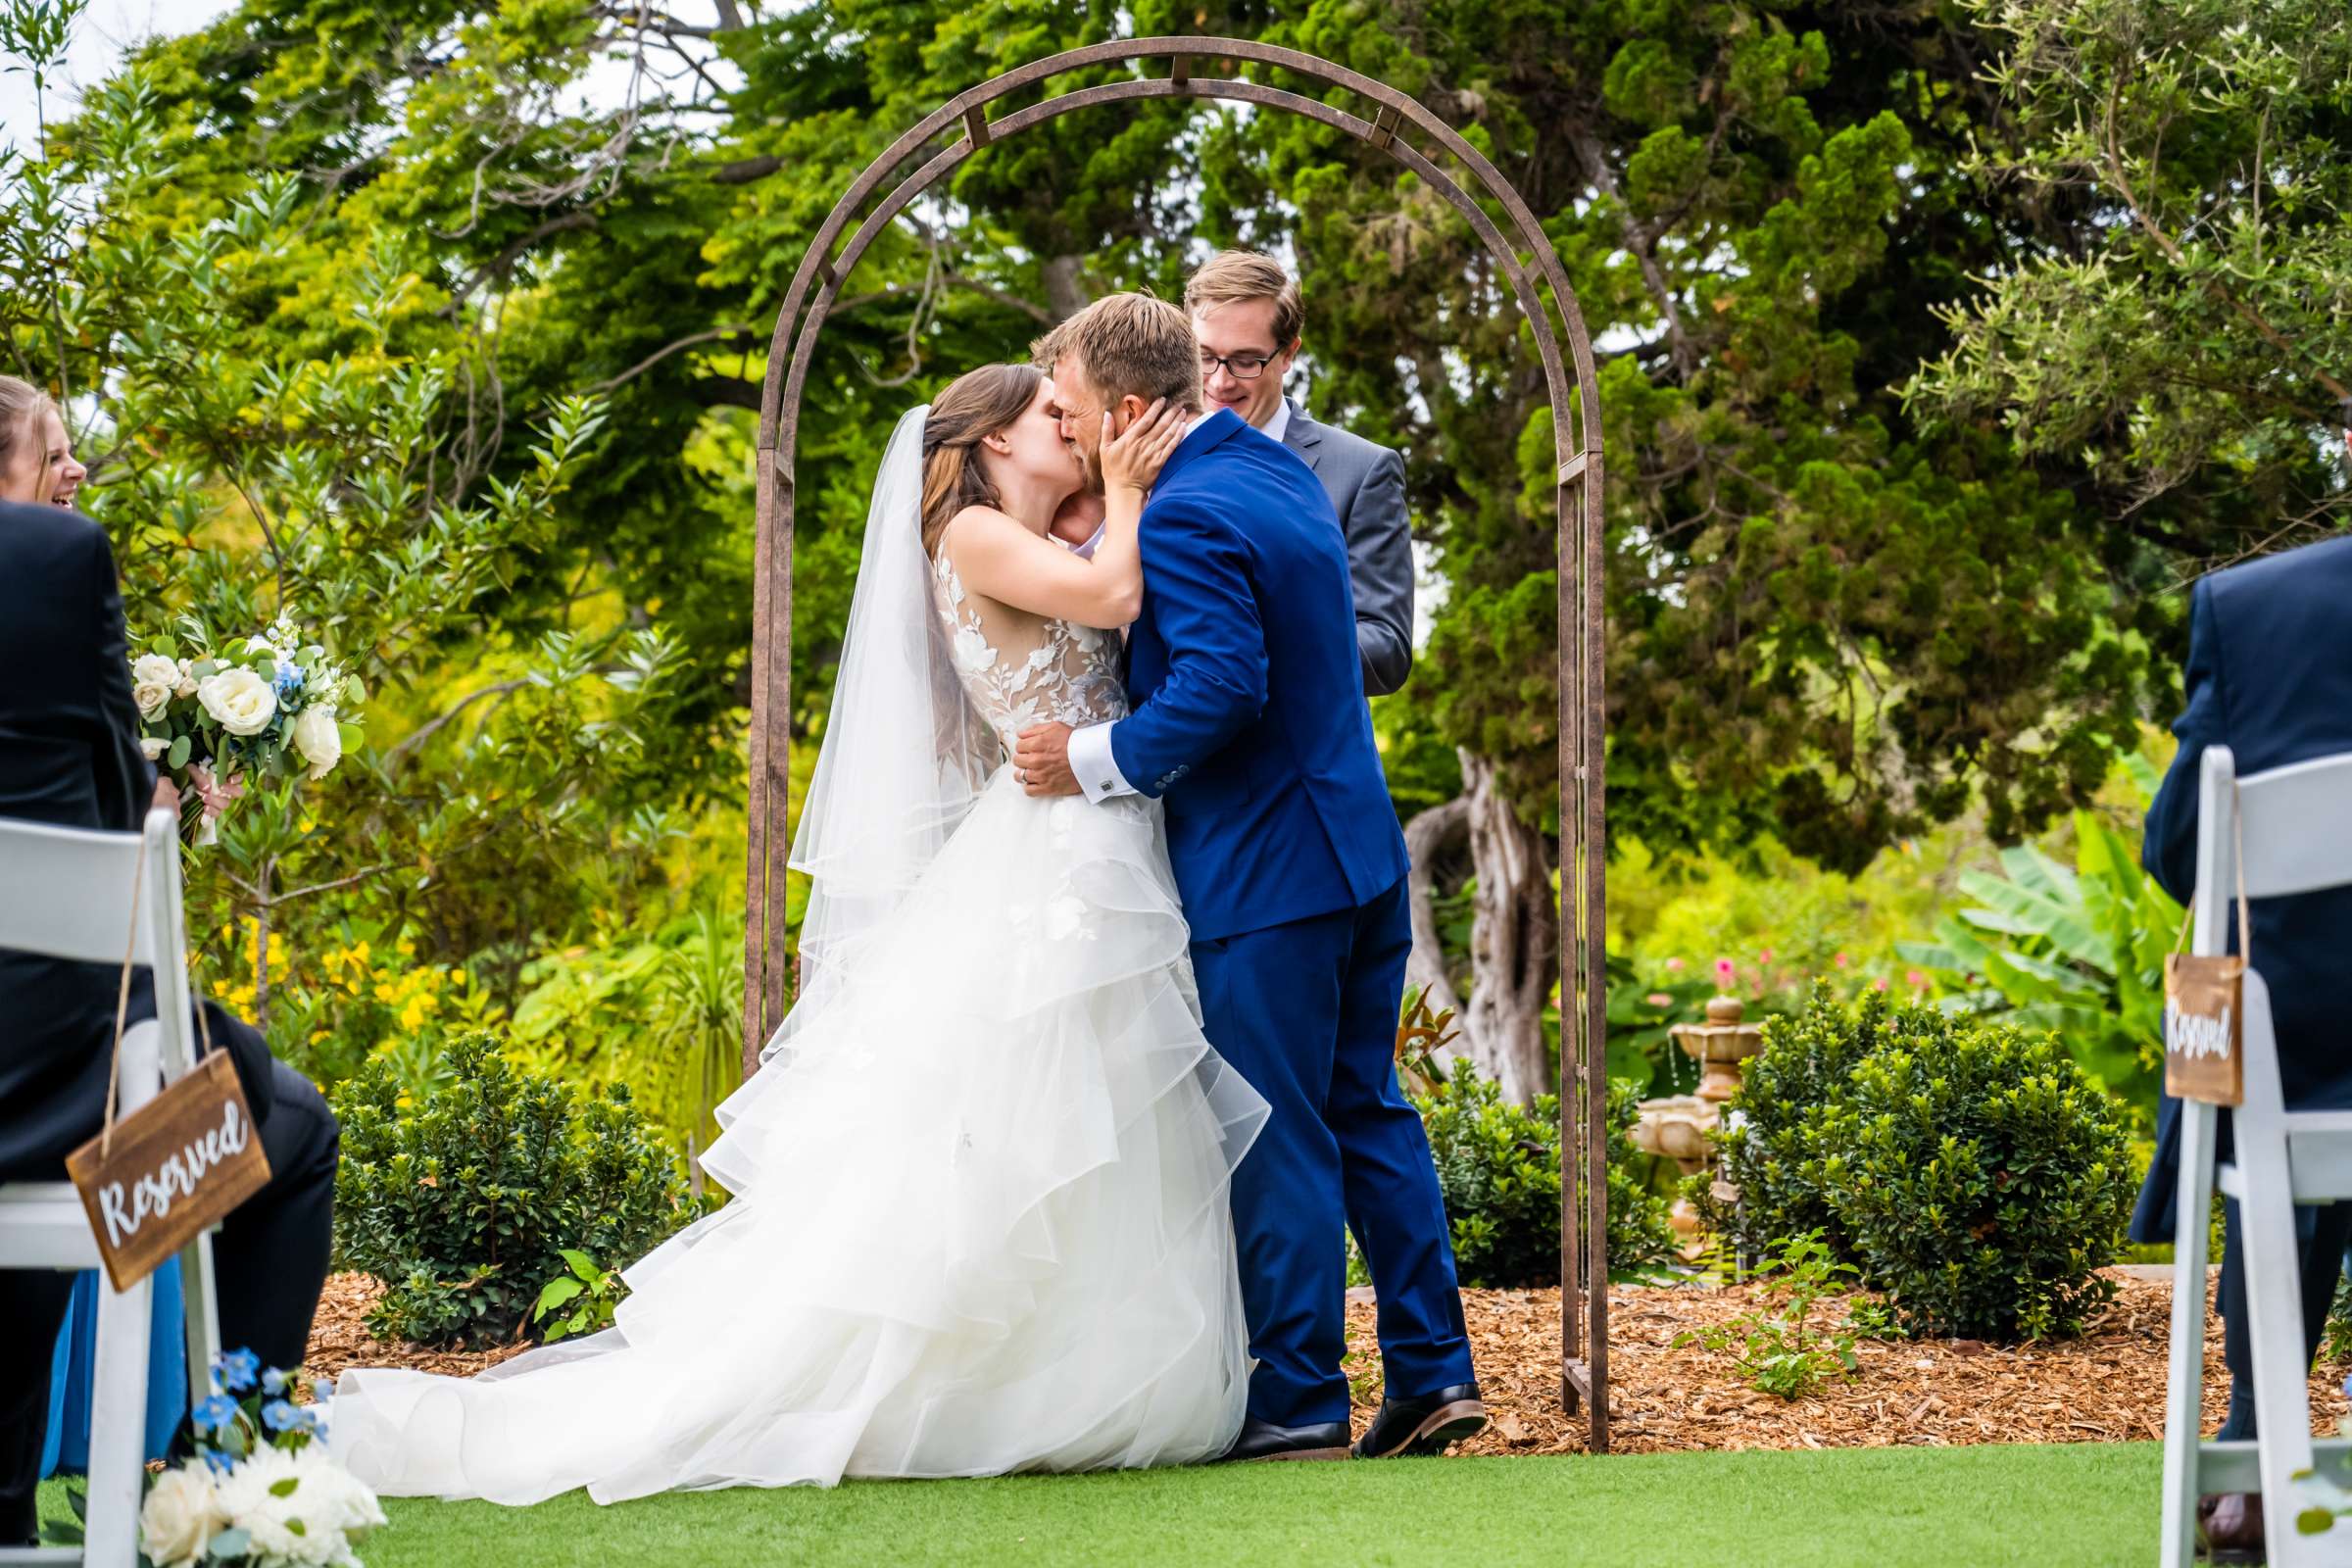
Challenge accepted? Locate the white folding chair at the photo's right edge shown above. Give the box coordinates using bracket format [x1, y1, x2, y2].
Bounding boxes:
[2164, 745, 2352, 1568]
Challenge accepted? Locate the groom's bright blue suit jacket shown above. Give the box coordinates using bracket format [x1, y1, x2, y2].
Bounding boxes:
[1110, 412, 1404, 941]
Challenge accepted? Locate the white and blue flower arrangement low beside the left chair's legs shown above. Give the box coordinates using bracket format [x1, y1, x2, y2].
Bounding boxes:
[139, 1349, 386, 1568]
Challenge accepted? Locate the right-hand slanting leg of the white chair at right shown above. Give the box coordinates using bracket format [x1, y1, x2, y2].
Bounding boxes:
[2236, 1121, 2340, 1568]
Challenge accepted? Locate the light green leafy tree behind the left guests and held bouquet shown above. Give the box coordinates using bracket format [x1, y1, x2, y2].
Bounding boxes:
[0, 0, 694, 1029]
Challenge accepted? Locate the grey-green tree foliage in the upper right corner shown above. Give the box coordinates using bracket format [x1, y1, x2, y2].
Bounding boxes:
[1910, 0, 2352, 557]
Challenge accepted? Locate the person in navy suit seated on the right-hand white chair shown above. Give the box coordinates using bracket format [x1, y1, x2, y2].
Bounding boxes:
[2131, 538, 2352, 1561]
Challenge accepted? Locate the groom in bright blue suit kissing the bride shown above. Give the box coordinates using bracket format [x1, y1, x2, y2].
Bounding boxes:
[1013, 294, 1487, 1460]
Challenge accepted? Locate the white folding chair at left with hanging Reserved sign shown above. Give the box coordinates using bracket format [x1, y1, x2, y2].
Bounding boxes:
[0, 811, 221, 1568]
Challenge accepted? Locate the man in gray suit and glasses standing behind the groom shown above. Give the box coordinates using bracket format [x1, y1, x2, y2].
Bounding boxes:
[1183, 252, 1413, 696]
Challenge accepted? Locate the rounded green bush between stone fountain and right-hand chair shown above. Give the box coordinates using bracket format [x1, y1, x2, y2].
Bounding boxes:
[1722, 987, 2135, 1340]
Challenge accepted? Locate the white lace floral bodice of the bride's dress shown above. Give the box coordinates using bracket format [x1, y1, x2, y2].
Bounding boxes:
[931, 546, 1127, 753]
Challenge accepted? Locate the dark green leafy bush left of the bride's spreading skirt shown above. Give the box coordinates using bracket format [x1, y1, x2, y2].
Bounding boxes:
[334, 1034, 692, 1345]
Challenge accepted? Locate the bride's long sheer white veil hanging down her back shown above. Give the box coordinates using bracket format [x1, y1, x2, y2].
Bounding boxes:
[762, 405, 1004, 1057]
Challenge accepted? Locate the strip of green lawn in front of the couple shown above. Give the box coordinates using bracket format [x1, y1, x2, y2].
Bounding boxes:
[42, 1444, 2162, 1568]
